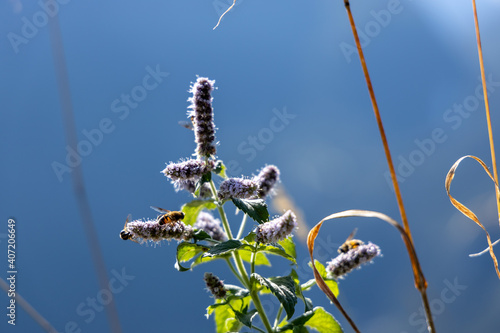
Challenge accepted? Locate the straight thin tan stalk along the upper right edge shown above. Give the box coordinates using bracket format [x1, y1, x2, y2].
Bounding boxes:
[472, 0, 500, 223]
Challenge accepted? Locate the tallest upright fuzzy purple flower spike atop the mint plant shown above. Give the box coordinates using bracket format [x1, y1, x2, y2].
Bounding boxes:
[188, 77, 216, 159]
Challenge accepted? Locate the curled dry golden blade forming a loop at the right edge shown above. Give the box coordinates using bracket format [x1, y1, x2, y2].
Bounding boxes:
[445, 155, 500, 279]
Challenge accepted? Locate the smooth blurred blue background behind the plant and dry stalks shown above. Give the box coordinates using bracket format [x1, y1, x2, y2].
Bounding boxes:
[0, 0, 500, 333]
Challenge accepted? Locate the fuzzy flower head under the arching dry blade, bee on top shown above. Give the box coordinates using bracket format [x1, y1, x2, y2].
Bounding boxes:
[326, 242, 381, 279]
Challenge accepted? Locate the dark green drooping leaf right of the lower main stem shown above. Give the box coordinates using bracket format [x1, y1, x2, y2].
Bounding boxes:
[251, 273, 297, 319]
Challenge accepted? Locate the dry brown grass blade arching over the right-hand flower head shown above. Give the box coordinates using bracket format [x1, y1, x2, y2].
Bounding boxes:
[307, 210, 435, 332]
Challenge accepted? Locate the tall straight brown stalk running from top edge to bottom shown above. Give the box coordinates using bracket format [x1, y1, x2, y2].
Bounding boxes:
[344, 0, 434, 333]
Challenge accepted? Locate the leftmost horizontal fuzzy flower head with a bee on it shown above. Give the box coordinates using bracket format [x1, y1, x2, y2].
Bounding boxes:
[120, 220, 194, 243]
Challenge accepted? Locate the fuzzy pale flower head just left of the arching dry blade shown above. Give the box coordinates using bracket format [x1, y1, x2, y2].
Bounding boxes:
[255, 210, 297, 244]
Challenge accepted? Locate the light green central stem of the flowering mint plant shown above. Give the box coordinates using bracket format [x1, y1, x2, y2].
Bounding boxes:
[210, 180, 274, 333]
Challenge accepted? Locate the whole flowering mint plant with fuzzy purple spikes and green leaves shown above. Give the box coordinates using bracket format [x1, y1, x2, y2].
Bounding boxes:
[120, 77, 380, 333]
